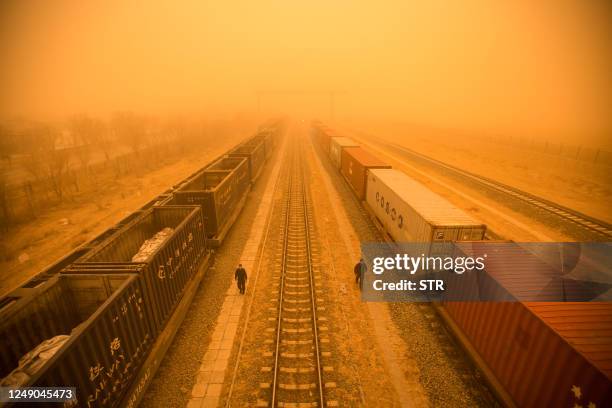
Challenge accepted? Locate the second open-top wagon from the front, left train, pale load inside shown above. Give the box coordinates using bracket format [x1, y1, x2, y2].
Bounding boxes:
[62, 206, 208, 330]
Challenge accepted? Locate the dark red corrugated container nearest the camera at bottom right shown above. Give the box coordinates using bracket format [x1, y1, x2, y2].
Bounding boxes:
[443, 242, 612, 407]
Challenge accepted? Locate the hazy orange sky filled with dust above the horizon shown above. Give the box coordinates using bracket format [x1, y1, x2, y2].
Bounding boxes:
[0, 0, 612, 143]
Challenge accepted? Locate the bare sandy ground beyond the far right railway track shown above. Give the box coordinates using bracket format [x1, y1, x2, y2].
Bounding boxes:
[346, 122, 612, 222]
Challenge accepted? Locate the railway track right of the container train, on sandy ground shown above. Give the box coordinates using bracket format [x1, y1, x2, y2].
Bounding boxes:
[379, 141, 612, 241]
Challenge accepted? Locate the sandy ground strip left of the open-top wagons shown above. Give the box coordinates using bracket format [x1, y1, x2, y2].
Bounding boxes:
[0, 132, 248, 295]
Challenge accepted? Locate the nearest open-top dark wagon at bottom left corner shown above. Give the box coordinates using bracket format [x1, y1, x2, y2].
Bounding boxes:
[0, 274, 155, 407]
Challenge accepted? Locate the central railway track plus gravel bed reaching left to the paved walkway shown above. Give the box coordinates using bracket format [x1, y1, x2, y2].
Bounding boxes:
[225, 138, 340, 408]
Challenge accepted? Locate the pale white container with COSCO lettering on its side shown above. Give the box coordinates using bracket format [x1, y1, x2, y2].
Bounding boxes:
[366, 169, 486, 242]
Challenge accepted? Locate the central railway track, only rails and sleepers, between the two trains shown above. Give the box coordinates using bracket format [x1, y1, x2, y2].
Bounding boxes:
[269, 143, 333, 407]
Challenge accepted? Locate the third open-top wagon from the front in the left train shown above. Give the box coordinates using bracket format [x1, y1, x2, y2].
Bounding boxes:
[166, 157, 250, 238]
